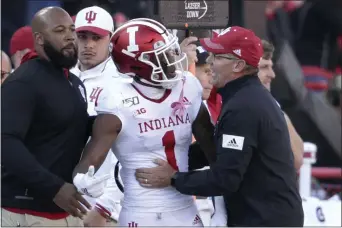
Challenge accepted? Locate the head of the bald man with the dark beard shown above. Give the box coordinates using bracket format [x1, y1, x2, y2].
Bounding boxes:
[41, 12, 77, 68]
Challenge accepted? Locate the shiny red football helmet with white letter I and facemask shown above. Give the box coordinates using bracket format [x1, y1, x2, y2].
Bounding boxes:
[112, 18, 187, 88]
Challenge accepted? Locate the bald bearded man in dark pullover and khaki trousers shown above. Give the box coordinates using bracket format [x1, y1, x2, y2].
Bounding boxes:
[1, 7, 90, 227]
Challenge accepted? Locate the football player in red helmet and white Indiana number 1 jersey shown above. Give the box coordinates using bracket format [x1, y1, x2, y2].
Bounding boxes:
[74, 19, 215, 227]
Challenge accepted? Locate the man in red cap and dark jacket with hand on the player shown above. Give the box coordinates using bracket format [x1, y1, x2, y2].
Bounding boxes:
[136, 26, 303, 226]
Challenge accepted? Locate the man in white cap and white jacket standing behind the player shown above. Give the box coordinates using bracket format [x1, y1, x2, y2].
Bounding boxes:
[71, 6, 127, 226]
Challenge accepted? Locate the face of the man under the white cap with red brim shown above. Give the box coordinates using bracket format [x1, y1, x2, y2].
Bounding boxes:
[77, 32, 110, 69]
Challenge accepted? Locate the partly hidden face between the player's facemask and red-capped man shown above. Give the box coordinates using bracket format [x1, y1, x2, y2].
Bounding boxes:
[196, 64, 213, 100]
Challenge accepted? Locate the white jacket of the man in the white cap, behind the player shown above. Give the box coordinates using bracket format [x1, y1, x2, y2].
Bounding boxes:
[70, 57, 128, 220]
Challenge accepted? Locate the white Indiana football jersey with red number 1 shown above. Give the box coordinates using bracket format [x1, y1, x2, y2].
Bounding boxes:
[95, 73, 202, 212]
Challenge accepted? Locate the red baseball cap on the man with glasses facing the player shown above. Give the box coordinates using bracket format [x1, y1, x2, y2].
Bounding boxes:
[200, 26, 263, 67]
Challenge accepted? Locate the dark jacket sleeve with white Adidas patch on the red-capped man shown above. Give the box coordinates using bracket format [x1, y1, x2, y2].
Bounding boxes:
[175, 110, 258, 196]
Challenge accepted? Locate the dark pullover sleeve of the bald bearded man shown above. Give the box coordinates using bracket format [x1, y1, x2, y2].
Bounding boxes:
[1, 81, 64, 199]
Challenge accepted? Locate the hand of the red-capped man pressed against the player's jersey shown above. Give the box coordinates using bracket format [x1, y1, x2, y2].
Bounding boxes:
[135, 159, 176, 188]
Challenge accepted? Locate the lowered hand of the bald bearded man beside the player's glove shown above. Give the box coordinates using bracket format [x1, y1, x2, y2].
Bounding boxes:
[53, 183, 91, 219]
